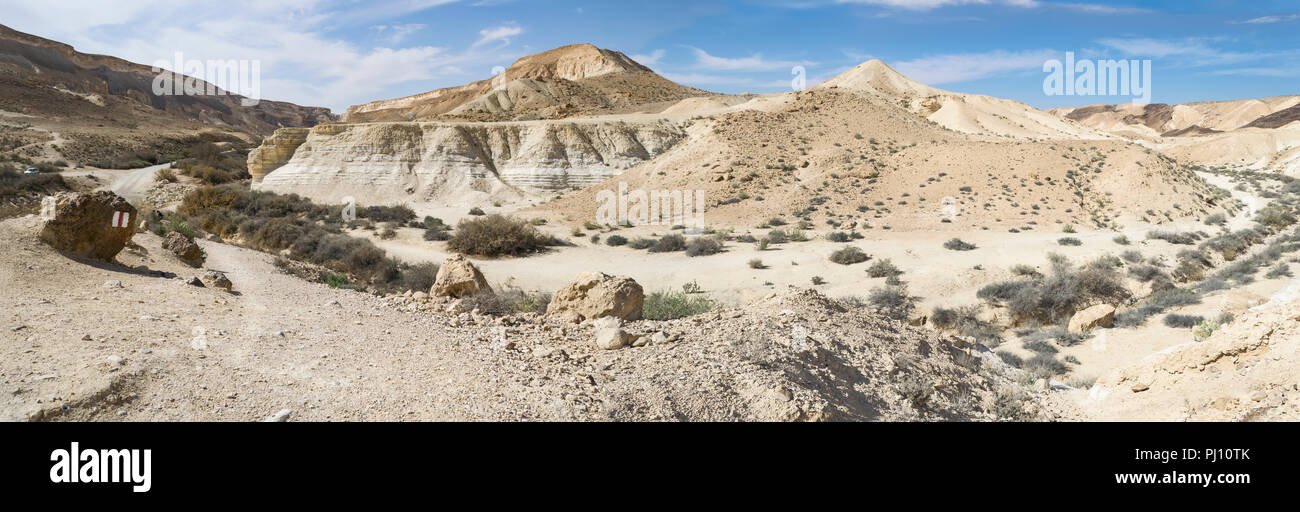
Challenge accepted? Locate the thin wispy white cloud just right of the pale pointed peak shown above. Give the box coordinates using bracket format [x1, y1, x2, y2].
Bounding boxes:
[894, 49, 1062, 84]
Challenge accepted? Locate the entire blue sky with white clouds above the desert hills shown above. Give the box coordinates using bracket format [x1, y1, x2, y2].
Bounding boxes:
[0, 0, 1300, 112]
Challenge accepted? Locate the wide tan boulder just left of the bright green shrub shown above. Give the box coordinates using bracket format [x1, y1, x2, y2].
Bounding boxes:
[546, 272, 646, 324]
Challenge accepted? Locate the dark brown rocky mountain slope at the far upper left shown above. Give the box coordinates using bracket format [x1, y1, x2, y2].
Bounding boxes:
[0, 26, 334, 135]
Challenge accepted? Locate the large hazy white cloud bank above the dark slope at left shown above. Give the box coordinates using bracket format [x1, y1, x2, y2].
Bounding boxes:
[3, 0, 523, 112]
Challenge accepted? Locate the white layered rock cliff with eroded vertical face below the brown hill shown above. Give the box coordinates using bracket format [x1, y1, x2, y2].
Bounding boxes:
[248, 121, 685, 205]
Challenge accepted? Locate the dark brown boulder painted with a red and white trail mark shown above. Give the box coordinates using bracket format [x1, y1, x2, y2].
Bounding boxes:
[40, 191, 137, 261]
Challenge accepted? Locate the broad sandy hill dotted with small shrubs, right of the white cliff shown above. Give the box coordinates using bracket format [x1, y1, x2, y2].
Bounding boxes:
[538, 79, 1217, 231]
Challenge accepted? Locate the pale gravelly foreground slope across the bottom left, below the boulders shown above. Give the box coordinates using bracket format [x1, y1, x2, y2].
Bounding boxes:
[0, 218, 1050, 421]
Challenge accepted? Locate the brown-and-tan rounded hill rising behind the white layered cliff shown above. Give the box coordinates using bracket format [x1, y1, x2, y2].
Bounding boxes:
[346, 44, 711, 122]
